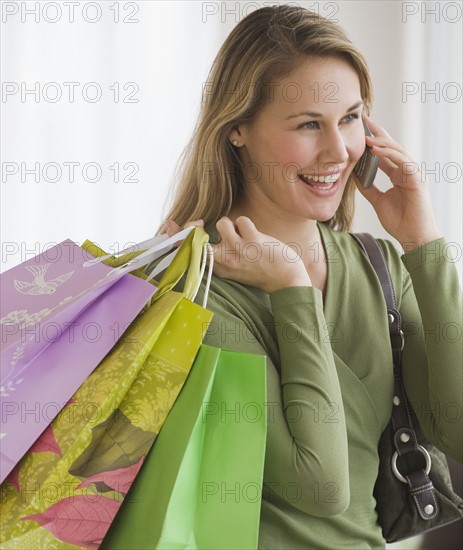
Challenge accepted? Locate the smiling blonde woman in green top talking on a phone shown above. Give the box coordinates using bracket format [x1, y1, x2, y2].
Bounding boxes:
[159, 6, 462, 550]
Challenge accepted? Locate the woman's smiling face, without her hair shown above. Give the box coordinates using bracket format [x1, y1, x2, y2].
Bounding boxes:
[234, 57, 365, 221]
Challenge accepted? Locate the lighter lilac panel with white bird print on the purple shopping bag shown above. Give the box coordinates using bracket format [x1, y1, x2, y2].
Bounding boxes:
[0, 239, 150, 387]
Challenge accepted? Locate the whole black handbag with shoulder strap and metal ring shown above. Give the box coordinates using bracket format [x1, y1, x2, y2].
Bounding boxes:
[352, 233, 463, 542]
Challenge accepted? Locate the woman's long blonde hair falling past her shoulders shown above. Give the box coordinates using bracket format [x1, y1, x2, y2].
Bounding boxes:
[160, 5, 373, 235]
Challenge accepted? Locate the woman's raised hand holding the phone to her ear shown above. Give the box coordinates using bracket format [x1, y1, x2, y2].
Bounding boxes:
[354, 117, 441, 250]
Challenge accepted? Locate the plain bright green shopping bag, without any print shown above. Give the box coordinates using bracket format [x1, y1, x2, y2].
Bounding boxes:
[100, 344, 267, 550]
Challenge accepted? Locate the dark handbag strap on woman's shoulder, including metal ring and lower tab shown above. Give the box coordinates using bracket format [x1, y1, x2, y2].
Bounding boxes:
[351, 233, 439, 520]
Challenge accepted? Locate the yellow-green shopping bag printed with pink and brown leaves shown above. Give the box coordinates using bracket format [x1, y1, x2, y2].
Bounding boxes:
[0, 228, 217, 548]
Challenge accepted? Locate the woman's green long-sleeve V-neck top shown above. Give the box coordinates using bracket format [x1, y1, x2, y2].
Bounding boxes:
[190, 223, 463, 550]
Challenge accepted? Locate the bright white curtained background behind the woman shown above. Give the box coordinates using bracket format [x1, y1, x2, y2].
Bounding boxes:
[0, 0, 463, 548]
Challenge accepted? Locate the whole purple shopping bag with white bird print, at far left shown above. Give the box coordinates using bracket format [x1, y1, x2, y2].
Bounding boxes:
[0, 239, 156, 483]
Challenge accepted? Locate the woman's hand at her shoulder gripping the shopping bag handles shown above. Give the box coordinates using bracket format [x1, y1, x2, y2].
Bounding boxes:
[166, 216, 312, 294]
